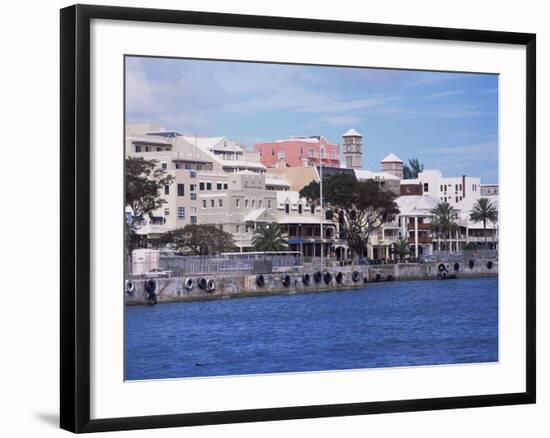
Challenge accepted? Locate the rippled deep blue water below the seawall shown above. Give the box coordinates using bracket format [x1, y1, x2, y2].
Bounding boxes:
[125, 278, 498, 380]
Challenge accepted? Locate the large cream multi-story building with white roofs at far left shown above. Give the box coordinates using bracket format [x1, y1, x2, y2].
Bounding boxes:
[126, 125, 290, 250]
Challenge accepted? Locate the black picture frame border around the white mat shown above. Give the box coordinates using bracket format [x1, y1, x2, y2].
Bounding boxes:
[60, 5, 536, 433]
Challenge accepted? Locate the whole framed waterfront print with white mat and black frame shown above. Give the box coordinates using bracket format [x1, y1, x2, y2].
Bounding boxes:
[61, 5, 536, 432]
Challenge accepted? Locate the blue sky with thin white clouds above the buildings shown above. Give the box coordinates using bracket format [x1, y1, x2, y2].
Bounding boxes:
[125, 57, 498, 184]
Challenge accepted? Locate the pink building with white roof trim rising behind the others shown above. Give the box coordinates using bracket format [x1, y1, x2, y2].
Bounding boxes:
[254, 136, 340, 167]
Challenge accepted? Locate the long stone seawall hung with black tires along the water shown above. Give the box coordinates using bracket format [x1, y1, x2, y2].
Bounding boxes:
[125, 260, 498, 305]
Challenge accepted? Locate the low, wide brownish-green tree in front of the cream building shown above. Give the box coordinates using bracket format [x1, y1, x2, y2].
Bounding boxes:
[156, 224, 238, 255]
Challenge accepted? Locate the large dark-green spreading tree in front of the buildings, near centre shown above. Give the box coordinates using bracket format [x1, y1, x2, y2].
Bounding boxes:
[300, 175, 399, 256]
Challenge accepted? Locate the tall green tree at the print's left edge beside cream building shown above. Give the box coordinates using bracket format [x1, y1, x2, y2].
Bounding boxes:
[124, 157, 174, 226]
